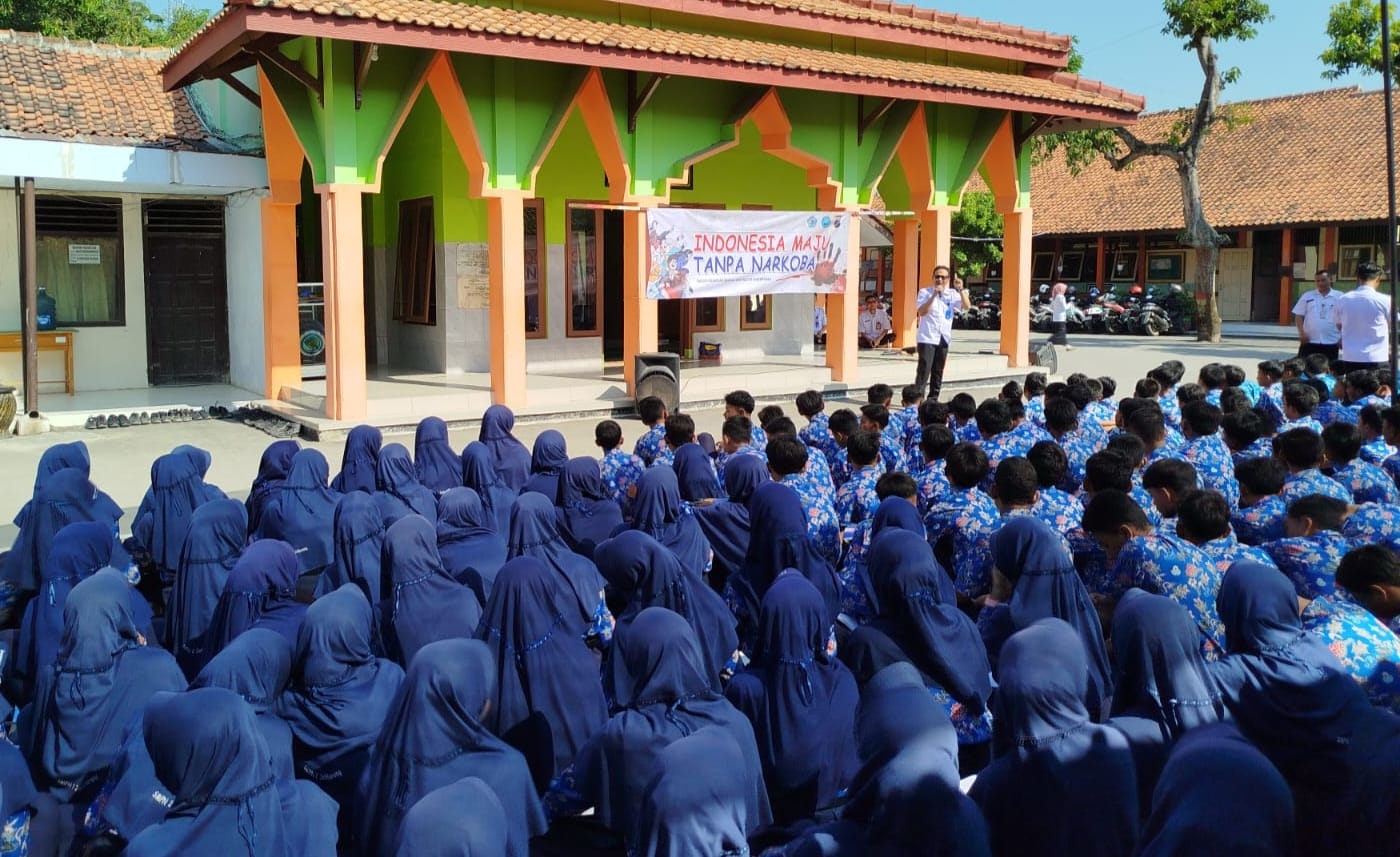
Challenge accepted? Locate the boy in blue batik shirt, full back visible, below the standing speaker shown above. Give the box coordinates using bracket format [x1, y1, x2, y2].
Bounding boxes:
[924, 444, 1001, 598]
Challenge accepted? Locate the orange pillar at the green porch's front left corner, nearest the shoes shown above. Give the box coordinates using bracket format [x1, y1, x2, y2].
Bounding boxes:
[316, 185, 370, 420]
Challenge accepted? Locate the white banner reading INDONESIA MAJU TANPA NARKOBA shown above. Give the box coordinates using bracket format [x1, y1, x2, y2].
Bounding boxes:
[647, 209, 851, 300]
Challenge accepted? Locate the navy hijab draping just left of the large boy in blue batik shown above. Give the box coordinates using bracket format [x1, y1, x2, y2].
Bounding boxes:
[987, 515, 1113, 721]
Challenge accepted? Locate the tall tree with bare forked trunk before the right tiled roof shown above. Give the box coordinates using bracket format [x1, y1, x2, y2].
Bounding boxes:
[1037, 0, 1273, 342]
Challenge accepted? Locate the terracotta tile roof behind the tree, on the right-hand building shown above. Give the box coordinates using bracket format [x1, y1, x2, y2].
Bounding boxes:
[1030, 87, 1386, 234]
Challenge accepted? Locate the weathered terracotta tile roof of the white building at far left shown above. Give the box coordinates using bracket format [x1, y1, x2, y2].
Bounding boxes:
[0, 31, 209, 148]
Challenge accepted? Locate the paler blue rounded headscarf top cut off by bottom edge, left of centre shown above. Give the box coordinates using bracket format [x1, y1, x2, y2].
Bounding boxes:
[395, 777, 507, 857]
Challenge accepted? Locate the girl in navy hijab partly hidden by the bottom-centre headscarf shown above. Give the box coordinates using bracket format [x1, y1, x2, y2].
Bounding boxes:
[545, 608, 773, 849]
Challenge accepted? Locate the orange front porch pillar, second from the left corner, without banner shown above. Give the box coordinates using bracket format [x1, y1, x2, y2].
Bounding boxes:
[486, 195, 523, 407]
